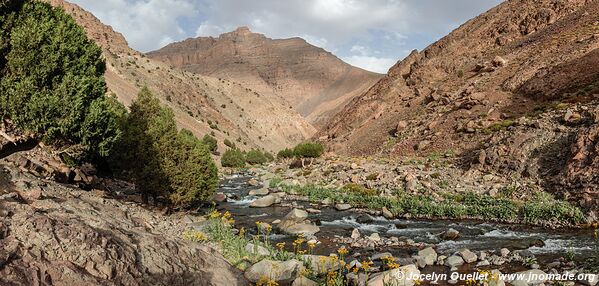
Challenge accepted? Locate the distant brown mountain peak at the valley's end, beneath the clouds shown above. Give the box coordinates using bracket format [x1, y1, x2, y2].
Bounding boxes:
[147, 27, 382, 126]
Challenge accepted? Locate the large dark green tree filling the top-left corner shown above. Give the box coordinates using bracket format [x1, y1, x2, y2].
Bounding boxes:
[0, 1, 121, 159]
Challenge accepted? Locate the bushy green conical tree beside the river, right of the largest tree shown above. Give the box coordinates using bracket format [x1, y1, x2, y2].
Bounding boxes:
[113, 88, 218, 205]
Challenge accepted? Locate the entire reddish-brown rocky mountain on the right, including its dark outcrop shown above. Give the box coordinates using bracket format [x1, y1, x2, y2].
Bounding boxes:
[322, 0, 599, 210]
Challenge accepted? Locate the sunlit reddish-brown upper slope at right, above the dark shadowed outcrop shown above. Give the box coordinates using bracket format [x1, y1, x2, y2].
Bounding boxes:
[318, 0, 598, 154]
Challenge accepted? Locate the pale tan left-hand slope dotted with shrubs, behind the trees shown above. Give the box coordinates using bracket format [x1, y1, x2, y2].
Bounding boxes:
[47, 0, 316, 151]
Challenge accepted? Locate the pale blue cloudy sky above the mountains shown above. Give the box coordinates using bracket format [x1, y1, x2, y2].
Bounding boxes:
[70, 0, 501, 73]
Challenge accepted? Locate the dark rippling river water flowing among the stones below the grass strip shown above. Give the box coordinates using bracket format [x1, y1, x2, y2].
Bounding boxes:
[219, 172, 594, 261]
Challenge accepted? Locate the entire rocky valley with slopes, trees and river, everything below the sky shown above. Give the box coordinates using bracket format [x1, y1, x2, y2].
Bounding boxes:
[0, 0, 599, 286]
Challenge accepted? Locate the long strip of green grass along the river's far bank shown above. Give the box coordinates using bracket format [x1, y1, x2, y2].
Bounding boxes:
[279, 185, 584, 226]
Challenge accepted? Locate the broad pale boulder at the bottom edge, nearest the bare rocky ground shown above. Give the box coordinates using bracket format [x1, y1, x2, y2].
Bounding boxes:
[244, 259, 302, 284]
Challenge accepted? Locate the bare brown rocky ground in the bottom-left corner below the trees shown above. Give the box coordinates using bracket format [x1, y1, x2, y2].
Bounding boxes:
[0, 153, 247, 285]
